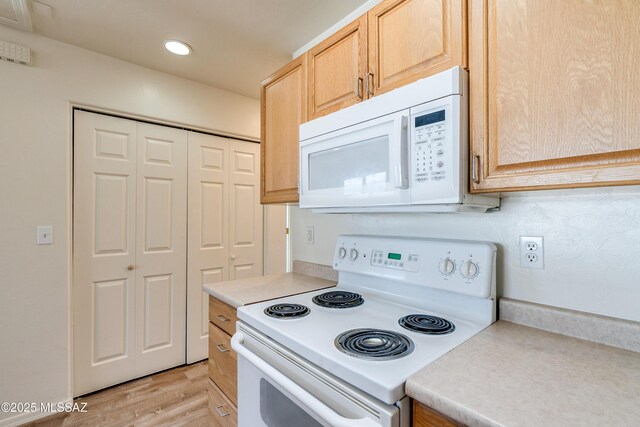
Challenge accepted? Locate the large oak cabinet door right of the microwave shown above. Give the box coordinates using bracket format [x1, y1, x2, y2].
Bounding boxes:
[469, 0, 640, 192]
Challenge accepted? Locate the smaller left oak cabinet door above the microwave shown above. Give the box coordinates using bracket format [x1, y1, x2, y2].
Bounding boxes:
[308, 15, 367, 120]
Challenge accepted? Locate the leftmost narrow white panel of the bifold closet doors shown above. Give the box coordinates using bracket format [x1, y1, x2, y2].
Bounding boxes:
[72, 111, 137, 396]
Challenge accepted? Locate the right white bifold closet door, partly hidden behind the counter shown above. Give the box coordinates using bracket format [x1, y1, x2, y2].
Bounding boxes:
[187, 132, 263, 363]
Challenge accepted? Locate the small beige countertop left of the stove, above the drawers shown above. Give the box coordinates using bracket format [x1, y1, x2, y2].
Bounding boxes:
[202, 273, 336, 308]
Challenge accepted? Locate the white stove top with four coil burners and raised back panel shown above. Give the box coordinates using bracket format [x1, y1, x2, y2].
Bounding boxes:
[238, 236, 495, 404]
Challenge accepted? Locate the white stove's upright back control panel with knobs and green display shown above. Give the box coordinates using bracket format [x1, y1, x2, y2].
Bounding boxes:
[333, 235, 496, 298]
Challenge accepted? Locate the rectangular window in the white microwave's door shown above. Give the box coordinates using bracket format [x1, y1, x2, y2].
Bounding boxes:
[309, 135, 390, 194]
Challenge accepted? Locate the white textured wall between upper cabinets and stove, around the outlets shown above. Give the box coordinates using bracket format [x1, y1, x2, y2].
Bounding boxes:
[291, 187, 640, 321]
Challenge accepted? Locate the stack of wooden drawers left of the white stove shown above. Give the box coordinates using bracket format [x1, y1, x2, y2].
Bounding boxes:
[208, 296, 238, 427]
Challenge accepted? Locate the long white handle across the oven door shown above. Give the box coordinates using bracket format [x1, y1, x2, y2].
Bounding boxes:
[231, 332, 380, 427]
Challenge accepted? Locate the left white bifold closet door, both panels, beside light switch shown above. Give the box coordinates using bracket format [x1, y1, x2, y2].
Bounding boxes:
[73, 112, 187, 396]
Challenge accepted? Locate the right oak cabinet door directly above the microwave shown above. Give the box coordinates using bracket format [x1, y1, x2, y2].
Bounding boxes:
[367, 0, 467, 96]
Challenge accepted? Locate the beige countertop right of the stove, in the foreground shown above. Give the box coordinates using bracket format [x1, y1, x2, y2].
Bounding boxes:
[406, 321, 640, 427]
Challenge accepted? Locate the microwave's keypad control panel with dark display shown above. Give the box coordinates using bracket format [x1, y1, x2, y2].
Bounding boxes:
[411, 110, 451, 183]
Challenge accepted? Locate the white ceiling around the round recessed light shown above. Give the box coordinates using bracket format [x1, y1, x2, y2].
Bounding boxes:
[8, 0, 366, 98]
